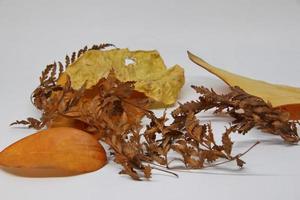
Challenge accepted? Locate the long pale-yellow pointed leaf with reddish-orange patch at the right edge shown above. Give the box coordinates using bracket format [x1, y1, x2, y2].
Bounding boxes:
[188, 52, 300, 120]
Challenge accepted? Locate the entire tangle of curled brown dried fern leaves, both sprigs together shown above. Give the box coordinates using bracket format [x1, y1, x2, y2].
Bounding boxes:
[13, 44, 299, 180]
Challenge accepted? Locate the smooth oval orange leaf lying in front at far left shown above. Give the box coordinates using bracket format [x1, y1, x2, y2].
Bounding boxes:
[0, 127, 107, 176]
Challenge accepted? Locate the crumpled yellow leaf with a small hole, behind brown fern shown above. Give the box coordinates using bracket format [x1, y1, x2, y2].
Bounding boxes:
[58, 49, 184, 107]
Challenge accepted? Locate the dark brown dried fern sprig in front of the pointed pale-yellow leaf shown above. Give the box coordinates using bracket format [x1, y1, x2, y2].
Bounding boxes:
[172, 86, 299, 143]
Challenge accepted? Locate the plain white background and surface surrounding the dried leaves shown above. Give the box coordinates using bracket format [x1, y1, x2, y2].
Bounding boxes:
[0, 0, 300, 200]
